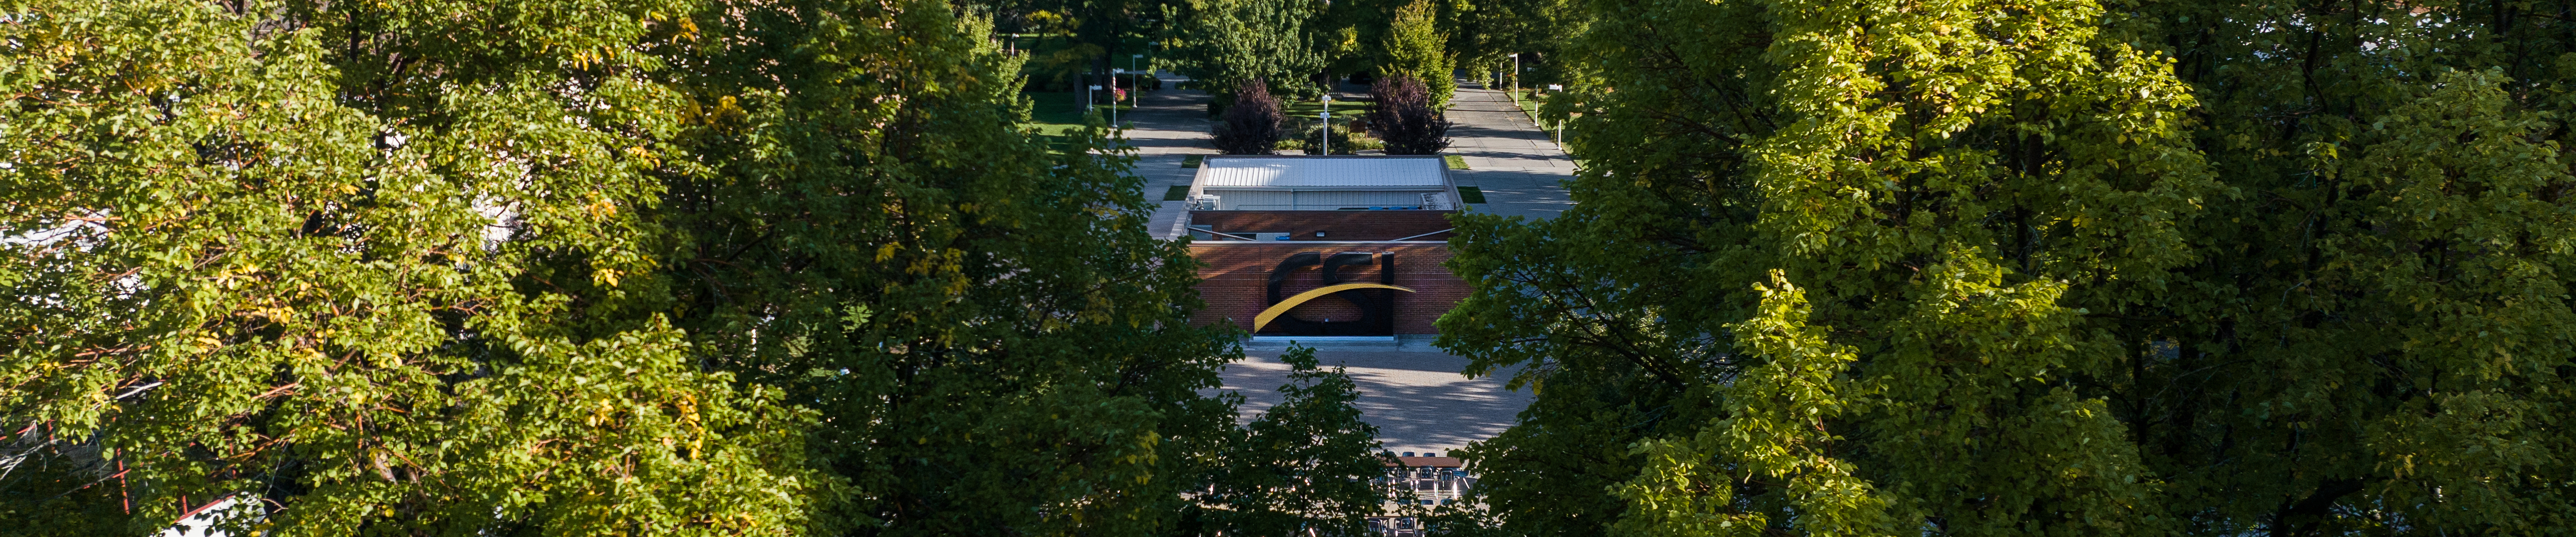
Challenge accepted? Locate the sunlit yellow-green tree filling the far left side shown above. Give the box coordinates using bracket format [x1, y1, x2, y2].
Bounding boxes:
[0, 0, 837, 535]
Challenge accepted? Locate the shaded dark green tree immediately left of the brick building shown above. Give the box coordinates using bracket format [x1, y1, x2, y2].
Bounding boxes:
[665, 2, 1239, 535]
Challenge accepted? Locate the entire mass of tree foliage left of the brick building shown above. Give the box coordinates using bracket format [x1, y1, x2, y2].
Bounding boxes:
[0, 0, 1378, 535]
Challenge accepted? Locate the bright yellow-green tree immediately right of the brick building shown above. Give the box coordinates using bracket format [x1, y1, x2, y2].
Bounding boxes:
[1442, 2, 2223, 535]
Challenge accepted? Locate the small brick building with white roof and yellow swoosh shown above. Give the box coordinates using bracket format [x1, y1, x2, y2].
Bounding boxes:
[1182, 155, 1468, 341]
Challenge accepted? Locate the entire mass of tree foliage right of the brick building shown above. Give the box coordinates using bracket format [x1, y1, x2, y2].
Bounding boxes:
[1442, 0, 2576, 535]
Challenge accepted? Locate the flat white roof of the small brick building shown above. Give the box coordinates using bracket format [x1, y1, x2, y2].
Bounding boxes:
[1198, 157, 1448, 188]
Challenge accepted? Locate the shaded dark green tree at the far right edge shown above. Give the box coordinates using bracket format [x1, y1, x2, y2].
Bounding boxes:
[2120, 2, 2576, 535]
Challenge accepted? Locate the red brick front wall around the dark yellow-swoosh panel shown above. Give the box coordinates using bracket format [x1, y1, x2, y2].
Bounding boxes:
[1190, 240, 1468, 333]
